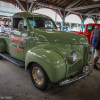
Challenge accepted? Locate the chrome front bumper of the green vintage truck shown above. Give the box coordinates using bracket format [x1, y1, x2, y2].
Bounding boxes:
[59, 63, 93, 86]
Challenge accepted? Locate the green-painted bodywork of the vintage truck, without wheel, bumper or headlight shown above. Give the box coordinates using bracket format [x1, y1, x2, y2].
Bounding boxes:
[0, 12, 90, 83]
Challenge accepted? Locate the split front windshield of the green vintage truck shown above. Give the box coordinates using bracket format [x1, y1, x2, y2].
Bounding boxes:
[28, 17, 57, 29]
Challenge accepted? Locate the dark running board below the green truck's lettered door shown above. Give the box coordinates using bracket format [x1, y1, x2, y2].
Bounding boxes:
[0, 53, 25, 68]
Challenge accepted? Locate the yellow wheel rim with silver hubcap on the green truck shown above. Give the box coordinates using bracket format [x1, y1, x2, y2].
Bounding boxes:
[32, 67, 44, 85]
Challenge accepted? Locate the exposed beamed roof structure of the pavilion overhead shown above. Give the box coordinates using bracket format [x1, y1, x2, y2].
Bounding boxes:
[0, 0, 100, 20]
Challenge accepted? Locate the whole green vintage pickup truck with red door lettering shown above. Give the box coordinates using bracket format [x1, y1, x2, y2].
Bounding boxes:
[0, 12, 93, 91]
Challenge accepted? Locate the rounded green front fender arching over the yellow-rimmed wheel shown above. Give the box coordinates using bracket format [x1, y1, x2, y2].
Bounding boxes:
[25, 48, 66, 82]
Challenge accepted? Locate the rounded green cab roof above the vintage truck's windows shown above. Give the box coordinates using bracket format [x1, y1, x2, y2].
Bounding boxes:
[13, 12, 52, 19]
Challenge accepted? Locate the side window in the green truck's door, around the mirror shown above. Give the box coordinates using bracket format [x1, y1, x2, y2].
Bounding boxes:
[13, 18, 27, 30]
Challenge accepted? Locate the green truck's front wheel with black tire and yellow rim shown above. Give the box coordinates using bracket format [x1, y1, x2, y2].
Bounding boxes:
[30, 63, 52, 91]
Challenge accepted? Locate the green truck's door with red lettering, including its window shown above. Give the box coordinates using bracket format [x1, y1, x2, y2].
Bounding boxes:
[9, 18, 29, 61]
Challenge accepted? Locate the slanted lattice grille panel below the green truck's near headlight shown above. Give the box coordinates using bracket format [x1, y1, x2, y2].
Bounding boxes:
[68, 59, 82, 74]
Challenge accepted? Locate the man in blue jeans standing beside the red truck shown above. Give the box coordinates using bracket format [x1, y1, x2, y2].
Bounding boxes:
[91, 26, 100, 52]
